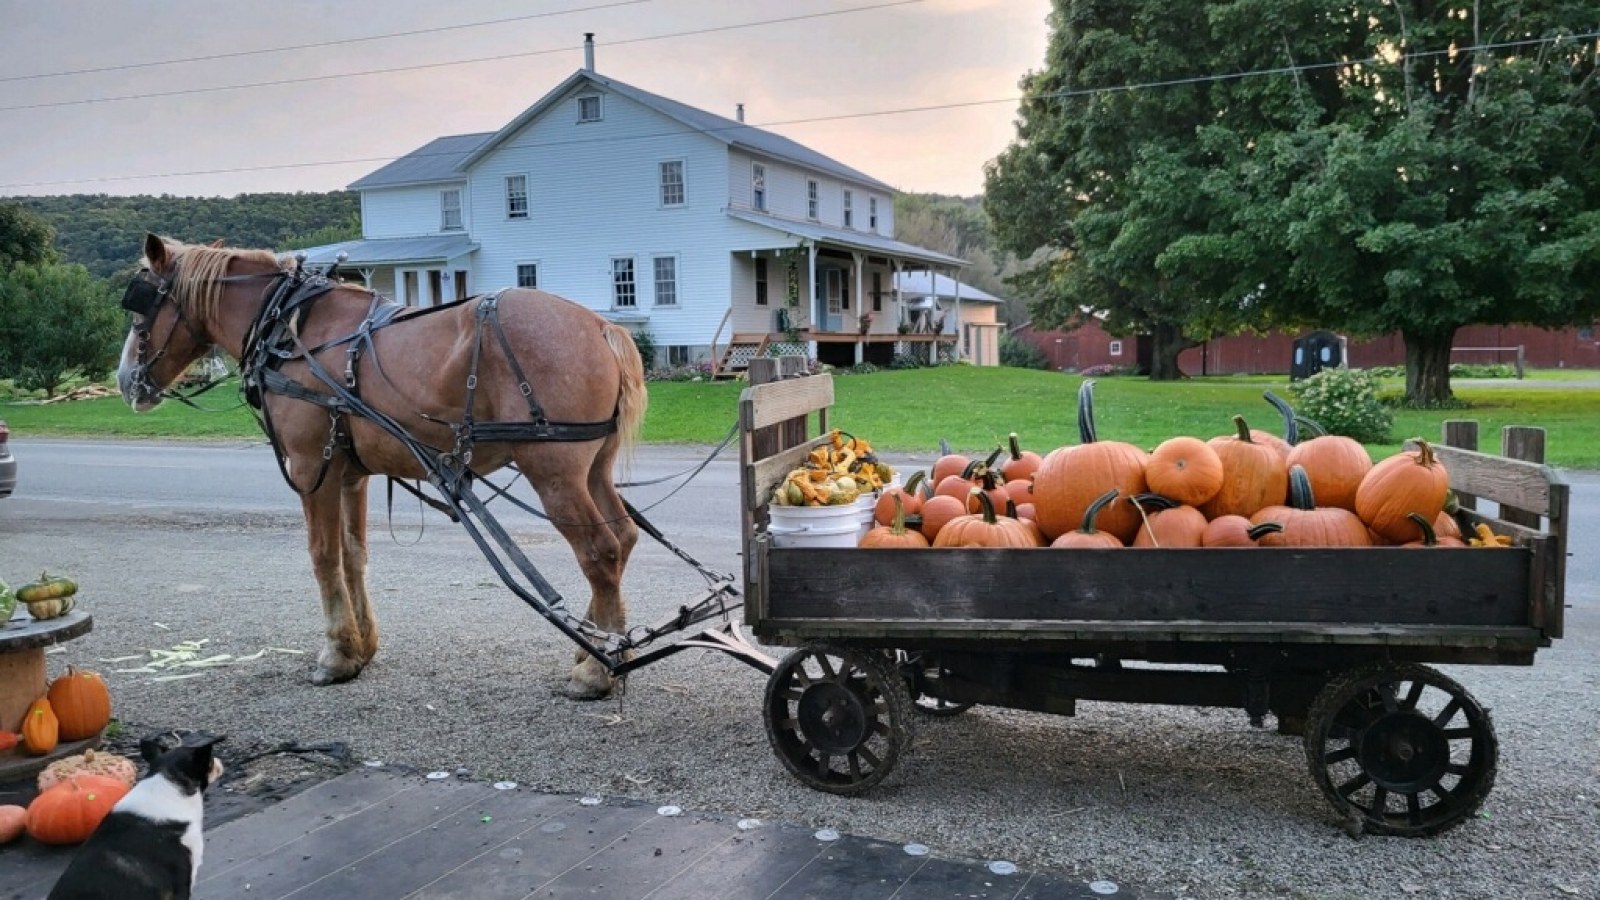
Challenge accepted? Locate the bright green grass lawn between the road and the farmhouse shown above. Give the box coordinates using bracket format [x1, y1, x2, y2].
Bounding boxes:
[0, 367, 1600, 469]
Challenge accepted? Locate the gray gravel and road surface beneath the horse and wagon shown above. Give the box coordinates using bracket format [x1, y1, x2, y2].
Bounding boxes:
[0, 445, 1600, 898]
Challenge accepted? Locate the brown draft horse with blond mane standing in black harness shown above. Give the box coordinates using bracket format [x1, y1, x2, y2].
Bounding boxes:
[117, 234, 646, 698]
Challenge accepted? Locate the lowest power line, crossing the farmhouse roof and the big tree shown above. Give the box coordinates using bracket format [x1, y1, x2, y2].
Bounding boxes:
[0, 30, 1600, 189]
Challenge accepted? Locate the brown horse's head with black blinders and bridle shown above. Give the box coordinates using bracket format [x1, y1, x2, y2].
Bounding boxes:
[117, 234, 277, 413]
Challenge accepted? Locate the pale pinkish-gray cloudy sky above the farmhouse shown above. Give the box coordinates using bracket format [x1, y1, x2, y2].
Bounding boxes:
[0, 0, 1050, 197]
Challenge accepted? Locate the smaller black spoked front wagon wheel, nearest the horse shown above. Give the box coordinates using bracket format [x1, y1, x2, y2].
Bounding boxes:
[763, 644, 914, 794]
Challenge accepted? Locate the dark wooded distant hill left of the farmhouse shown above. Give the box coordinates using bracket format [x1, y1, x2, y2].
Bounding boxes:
[6, 191, 362, 277]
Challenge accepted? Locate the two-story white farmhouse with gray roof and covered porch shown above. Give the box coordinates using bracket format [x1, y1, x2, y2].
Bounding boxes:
[307, 35, 972, 372]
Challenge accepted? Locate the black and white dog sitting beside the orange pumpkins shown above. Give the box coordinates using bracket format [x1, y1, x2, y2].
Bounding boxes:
[50, 733, 222, 900]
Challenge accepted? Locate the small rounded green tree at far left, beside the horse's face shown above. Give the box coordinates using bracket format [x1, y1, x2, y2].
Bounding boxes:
[0, 264, 122, 396]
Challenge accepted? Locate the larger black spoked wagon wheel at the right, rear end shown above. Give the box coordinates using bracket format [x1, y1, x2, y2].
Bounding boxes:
[1306, 663, 1499, 838]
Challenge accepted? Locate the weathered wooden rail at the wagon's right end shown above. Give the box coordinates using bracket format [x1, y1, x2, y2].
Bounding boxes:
[1434, 421, 1571, 637]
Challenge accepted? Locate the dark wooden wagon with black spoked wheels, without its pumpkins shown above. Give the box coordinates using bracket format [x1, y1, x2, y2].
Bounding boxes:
[739, 376, 1568, 836]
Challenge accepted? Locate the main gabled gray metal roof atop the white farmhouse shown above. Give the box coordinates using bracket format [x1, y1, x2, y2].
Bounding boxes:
[457, 69, 894, 191]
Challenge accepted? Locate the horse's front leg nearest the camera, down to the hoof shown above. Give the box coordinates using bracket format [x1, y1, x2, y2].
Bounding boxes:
[301, 472, 363, 685]
